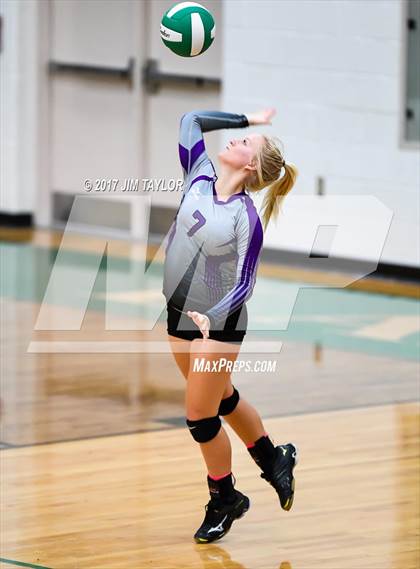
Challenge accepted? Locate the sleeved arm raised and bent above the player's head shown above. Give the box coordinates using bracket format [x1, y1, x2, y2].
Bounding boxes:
[179, 111, 249, 190]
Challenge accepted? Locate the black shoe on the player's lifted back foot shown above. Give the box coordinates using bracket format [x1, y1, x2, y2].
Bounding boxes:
[261, 443, 298, 510]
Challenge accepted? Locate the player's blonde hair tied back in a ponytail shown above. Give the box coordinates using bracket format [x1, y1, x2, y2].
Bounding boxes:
[246, 134, 299, 230]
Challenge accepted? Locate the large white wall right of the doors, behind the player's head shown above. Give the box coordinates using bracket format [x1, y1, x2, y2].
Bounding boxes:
[223, 0, 420, 266]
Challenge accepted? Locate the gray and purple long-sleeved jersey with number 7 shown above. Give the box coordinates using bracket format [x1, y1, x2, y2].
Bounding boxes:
[163, 111, 263, 329]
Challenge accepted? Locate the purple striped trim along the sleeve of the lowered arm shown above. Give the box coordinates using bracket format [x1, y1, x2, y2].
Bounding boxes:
[208, 197, 263, 322]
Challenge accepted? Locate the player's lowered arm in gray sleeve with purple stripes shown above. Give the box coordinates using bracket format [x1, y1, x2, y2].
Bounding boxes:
[204, 197, 263, 330]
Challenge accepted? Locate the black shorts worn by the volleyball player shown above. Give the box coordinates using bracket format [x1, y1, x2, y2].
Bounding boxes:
[166, 301, 248, 344]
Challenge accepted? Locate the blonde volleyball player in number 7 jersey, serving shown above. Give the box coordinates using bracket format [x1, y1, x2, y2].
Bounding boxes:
[163, 108, 298, 543]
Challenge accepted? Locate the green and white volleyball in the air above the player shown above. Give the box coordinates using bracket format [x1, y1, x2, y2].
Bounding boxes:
[160, 2, 216, 57]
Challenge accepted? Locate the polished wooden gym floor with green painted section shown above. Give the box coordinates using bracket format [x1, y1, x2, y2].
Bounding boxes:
[0, 230, 420, 569]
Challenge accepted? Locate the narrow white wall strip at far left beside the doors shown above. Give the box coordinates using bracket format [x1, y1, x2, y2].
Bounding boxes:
[0, 0, 40, 213]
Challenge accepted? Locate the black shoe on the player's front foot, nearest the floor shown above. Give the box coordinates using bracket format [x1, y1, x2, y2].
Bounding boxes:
[194, 490, 250, 543]
